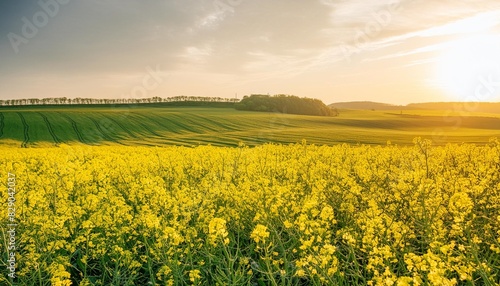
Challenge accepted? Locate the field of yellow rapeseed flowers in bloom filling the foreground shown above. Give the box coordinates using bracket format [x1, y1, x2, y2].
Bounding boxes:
[0, 139, 500, 285]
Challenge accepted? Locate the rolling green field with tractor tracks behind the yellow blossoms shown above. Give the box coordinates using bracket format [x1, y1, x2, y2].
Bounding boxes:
[0, 106, 500, 147]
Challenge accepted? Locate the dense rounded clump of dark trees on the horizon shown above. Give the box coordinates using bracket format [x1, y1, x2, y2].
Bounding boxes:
[235, 94, 338, 116]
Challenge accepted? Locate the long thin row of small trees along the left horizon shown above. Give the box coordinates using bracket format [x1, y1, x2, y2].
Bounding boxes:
[0, 95, 239, 106]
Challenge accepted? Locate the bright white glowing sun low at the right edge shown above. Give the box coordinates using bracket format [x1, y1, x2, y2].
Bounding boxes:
[436, 34, 500, 101]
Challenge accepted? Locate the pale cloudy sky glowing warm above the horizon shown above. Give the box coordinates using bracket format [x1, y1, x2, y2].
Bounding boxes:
[0, 0, 500, 104]
